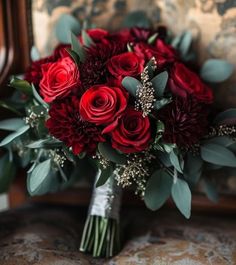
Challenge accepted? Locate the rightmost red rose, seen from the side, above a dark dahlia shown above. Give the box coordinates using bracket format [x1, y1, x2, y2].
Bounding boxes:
[169, 63, 213, 103]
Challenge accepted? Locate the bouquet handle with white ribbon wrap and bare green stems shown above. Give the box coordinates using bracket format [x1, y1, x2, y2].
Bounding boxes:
[80, 170, 122, 258]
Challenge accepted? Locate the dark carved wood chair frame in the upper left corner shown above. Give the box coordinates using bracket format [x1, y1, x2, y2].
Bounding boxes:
[0, 0, 32, 92]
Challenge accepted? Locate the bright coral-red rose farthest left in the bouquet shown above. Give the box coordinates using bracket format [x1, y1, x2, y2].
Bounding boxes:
[39, 57, 79, 103]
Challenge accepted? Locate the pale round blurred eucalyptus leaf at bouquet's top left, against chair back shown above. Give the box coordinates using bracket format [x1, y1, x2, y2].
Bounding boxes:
[55, 14, 80, 43]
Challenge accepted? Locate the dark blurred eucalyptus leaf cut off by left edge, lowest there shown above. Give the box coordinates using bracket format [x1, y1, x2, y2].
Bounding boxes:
[0, 154, 16, 193]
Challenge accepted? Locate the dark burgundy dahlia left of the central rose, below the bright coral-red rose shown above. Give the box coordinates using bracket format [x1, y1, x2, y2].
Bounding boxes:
[46, 97, 104, 155]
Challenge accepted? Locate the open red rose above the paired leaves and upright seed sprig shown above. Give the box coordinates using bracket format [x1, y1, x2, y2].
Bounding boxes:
[107, 52, 143, 78]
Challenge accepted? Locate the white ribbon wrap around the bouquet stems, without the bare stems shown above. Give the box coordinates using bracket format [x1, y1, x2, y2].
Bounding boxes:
[89, 170, 122, 221]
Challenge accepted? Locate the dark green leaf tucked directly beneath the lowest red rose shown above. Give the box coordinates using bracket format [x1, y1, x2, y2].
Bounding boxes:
[98, 142, 126, 164]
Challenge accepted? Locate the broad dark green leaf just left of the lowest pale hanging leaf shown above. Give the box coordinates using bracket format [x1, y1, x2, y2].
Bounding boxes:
[144, 169, 173, 211]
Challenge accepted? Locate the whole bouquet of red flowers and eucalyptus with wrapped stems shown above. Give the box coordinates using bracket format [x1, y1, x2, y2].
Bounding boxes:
[0, 13, 236, 257]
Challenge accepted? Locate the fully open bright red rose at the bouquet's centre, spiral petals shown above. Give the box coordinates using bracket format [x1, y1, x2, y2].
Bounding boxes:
[80, 85, 128, 133]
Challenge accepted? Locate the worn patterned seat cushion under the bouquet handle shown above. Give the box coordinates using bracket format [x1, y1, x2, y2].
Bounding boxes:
[0, 205, 236, 265]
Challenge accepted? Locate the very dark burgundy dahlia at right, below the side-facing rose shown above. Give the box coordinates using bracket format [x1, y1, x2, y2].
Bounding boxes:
[158, 97, 208, 148]
